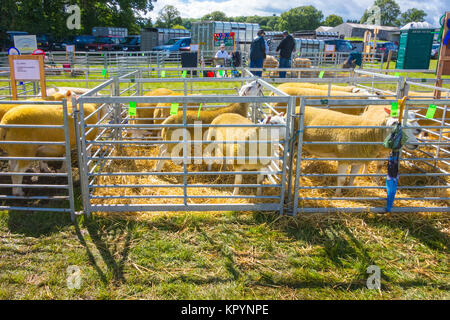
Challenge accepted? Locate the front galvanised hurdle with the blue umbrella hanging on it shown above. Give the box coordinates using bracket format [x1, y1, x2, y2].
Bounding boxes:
[288, 97, 450, 215]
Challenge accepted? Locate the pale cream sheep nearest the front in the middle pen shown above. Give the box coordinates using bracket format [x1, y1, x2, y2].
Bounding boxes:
[205, 113, 286, 196]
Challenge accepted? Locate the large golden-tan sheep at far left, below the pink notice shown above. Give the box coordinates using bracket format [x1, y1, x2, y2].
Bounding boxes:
[0, 97, 101, 196]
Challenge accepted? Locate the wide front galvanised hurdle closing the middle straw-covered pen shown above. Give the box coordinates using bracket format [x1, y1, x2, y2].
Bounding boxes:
[78, 77, 295, 214]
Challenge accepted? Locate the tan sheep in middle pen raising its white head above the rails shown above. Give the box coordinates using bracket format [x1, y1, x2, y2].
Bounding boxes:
[154, 81, 262, 172]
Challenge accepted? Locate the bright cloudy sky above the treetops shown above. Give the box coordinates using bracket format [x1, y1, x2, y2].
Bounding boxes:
[147, 0, 450, 27]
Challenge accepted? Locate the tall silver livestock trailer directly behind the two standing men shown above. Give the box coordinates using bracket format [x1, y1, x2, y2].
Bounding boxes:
[191, 21, 259, 58]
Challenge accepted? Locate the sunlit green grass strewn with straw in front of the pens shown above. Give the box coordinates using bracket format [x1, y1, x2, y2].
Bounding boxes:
[0, 212, 450, 299]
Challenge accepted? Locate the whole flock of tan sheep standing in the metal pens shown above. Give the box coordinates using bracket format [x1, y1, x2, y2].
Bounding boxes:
[0, 81, 442, 196]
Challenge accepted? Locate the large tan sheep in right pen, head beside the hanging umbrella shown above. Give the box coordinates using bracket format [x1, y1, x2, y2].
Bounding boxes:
[295, 107, 418, 196]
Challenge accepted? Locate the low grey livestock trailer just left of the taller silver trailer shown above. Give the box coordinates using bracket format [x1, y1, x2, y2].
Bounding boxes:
[141, 28, 191, 51]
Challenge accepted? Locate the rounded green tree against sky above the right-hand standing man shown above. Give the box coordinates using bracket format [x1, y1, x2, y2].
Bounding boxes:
[278, 6, 323, 32]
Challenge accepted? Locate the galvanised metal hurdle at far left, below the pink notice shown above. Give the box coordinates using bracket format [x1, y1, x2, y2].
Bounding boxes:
[0, 100, 75, 220]
